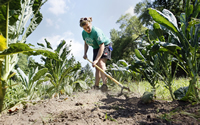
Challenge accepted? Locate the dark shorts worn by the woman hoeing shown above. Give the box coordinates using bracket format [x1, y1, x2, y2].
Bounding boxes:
[93, 43, 112, 61]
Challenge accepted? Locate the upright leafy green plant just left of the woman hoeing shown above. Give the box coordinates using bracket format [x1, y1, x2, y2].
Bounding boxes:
[38, 39, 84, 97]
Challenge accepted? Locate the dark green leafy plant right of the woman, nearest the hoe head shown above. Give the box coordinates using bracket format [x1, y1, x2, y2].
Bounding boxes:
[129, 44, 160, 95]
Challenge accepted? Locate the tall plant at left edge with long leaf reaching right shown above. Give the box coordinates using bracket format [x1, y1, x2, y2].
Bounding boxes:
[0, 0, 57, 112]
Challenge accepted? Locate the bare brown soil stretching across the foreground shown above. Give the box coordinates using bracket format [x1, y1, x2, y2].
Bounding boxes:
[0, 90, 200, 125]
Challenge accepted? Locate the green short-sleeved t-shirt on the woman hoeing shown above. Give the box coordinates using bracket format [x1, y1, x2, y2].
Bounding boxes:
[82, 26, 110, 49]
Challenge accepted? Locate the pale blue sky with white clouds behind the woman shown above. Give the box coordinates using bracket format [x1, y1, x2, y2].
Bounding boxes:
[27, 0, 142, 69]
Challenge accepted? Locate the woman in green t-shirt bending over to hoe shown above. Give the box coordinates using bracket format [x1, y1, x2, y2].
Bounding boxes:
[80, 17, 112, 91]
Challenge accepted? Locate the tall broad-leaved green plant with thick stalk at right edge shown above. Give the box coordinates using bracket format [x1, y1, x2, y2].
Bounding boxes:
[149, 0, 200, 100]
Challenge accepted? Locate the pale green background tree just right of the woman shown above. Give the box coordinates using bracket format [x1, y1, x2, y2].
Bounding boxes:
[110, 14, 146, 63]
